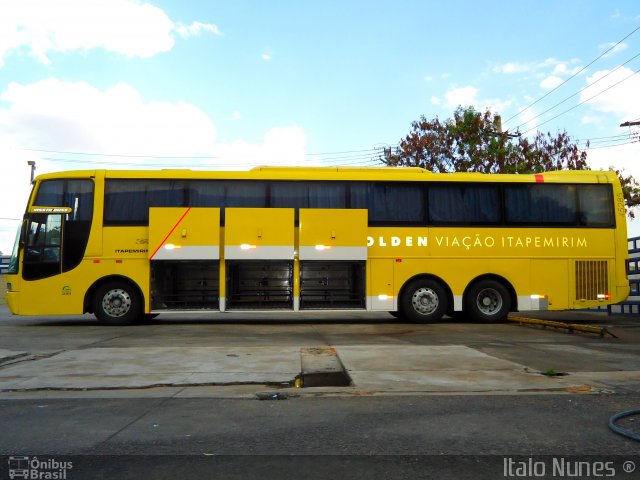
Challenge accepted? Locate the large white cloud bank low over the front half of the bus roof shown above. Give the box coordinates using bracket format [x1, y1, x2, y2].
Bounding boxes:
[0, 79, 310, 253]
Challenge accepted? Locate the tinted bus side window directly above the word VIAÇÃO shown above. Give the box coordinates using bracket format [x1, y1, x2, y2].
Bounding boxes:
[429, 184, 501, 224]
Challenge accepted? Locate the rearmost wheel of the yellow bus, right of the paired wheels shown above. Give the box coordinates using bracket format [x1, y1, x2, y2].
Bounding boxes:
[465, 280, 511, 323]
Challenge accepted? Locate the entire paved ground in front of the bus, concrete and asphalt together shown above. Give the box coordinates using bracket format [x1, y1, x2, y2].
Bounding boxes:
[0, 306, 640, 479]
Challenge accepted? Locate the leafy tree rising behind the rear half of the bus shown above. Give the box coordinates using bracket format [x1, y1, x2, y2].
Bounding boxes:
[381, 106, 640, 217]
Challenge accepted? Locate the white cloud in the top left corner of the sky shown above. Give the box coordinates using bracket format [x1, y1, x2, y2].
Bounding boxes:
[0, 0, 221, 66]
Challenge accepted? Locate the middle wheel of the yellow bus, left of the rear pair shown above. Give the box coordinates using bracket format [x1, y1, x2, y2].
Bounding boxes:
[400, 278, 448, 323]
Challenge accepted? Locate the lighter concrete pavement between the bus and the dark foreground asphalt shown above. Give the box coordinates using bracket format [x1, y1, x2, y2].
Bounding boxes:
[0, 306, 640, 398]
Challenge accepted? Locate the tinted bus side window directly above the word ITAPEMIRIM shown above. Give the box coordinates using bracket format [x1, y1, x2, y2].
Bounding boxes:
[504, 184, 577, 225]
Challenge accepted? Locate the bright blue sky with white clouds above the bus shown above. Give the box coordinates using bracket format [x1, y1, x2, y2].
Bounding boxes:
[0, 0, 640, 253]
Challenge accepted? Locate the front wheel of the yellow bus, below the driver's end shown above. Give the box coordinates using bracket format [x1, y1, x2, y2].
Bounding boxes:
[93, 281, 142, 325]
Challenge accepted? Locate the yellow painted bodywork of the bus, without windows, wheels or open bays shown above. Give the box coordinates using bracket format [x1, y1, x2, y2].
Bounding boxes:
[7, 167, 629, 315]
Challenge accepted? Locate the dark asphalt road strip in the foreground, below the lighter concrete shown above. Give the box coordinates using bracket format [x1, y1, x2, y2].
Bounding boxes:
[0, 394, 640, 478]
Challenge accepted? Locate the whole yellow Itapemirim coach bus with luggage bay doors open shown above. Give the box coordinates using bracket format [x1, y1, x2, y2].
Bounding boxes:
[7, 167, 629, 324]
